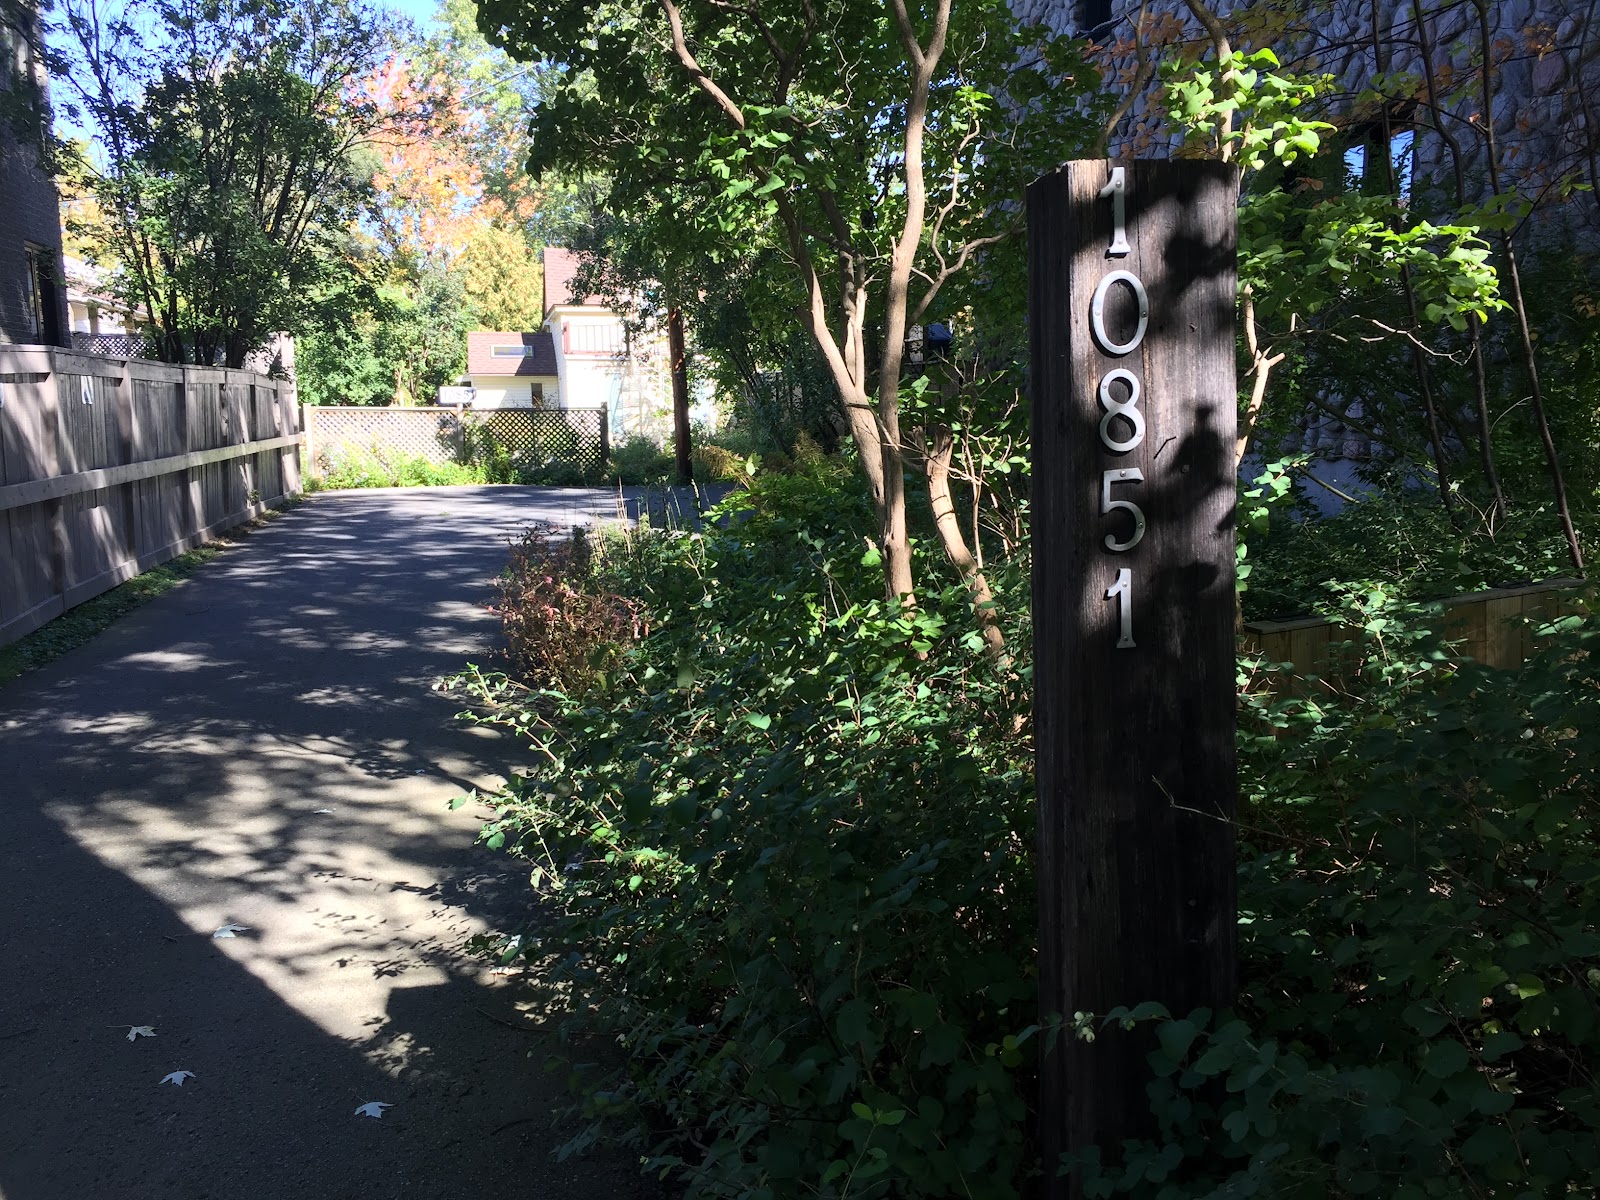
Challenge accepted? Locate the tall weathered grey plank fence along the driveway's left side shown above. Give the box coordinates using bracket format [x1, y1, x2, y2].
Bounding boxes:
[0, 346, 301, 645]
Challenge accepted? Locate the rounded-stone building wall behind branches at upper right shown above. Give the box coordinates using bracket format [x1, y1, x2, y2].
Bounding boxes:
[1013, 0, 1600, 245]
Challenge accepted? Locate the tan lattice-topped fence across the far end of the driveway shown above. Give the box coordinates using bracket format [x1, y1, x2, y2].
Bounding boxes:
[304, 405, 610, 478]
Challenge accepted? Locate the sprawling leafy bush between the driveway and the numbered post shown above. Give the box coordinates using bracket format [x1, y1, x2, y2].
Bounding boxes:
[457, 475, 1037, 1198]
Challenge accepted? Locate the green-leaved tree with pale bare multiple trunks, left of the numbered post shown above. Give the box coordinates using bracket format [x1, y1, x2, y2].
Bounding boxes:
[478, 0, 1093, 646]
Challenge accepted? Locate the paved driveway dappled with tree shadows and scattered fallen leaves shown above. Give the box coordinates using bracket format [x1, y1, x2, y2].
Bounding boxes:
[0, 488, 672, 1200]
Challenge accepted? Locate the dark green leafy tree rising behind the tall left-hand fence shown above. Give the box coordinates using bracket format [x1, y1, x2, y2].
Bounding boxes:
[54, 0, 389, 366]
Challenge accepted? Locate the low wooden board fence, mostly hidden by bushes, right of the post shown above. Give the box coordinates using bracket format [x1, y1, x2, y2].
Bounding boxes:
[1240, 579, 1594, 677]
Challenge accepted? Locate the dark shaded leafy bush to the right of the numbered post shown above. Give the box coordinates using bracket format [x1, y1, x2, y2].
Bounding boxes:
[1062, 602, 1600, 1200]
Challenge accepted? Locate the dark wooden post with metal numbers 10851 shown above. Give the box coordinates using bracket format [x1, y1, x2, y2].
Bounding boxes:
[1027, 160, 1237, 1200]
